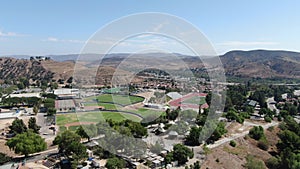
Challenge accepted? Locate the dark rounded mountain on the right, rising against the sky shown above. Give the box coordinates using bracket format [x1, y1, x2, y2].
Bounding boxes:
[220, 50, 300, 78]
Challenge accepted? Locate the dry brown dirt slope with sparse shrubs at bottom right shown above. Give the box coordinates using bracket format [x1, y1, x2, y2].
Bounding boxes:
[201, 127, 280, 169]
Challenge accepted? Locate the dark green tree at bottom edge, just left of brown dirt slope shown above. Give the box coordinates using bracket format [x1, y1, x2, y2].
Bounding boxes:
[173, 144, 194, 165]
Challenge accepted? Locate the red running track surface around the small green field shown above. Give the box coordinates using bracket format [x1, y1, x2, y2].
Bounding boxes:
[169, 93, 209, 109]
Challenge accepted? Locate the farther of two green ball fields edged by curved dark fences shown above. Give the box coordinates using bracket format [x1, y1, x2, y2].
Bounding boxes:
[97, 94, 144, 105]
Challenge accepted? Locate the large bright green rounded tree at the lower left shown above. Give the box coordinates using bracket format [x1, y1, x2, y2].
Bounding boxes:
[6, 130, 47, 157]
